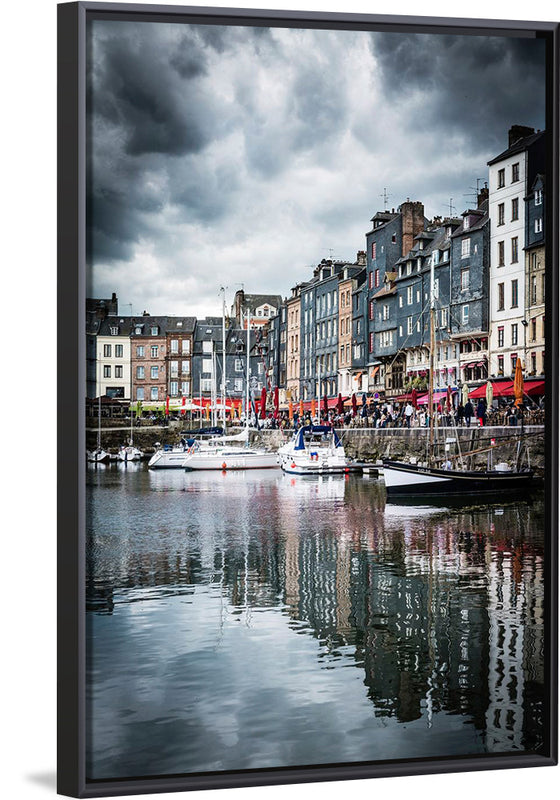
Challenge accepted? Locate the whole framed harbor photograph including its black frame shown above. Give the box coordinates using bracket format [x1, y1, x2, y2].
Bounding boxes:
[58, 2, 559, 797]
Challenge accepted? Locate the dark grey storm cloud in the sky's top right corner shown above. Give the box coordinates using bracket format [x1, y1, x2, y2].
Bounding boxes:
[371, 33, 545, 154]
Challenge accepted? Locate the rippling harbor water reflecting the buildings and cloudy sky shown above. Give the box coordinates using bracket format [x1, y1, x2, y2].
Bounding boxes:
[87, 463, 544, 780]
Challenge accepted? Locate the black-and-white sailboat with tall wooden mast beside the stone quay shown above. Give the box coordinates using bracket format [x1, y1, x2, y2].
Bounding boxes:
[383, 261, 534, 499]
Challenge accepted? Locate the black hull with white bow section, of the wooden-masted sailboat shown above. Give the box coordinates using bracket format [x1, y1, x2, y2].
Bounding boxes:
[383, 461, 534, 496]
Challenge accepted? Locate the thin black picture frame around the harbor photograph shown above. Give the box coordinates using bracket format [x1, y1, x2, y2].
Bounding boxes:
[58, 2, 560, 797]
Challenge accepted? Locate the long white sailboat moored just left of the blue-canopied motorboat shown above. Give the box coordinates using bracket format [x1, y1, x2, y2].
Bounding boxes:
[183, 300, 278, 472]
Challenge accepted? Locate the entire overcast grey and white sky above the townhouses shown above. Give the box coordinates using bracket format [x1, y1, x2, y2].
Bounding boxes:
[88, 21, 544, 317]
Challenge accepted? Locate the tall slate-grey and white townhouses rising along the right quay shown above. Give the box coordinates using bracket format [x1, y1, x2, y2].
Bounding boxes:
[267, 125, 545, 402]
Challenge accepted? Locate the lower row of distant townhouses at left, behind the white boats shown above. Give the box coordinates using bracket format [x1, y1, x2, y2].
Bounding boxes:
[86, 291, 282, 403]
